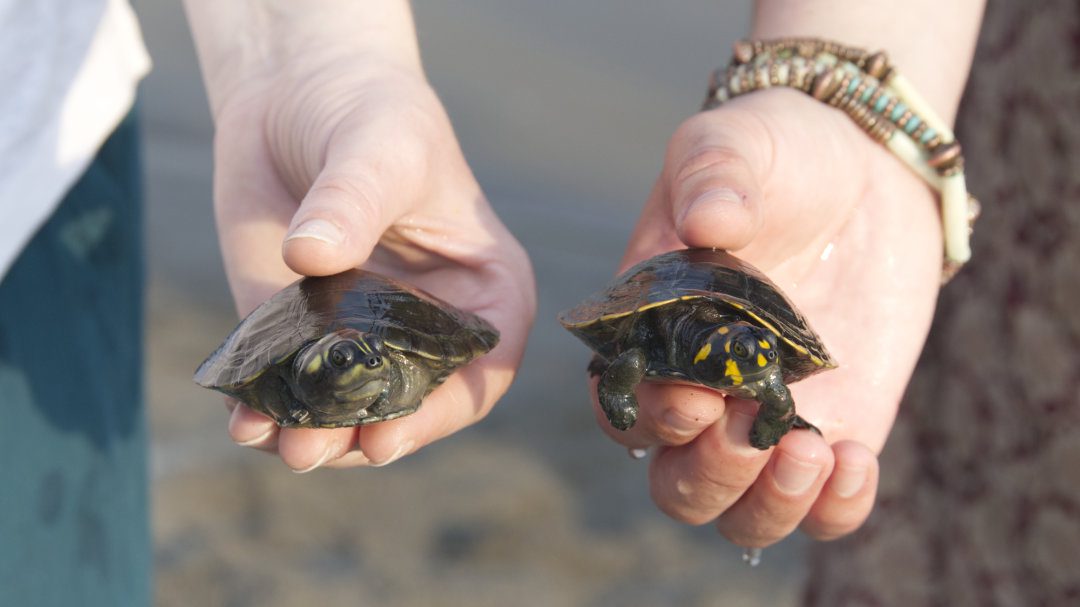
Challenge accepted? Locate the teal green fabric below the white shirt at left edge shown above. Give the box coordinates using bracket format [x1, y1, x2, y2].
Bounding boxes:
[0, 111, 152, 607]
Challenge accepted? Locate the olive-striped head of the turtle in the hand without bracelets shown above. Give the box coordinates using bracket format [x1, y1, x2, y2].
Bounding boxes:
[292, 329, 392, 416]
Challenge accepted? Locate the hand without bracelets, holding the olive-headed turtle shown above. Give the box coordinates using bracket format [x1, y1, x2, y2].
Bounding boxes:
[206, 54, 536, 471]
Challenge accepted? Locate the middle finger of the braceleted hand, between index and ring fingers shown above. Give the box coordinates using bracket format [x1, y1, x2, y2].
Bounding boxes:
[649, 399, 770, 525]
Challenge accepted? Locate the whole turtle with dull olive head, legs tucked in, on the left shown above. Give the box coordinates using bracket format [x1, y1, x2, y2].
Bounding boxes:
[194, 269, 499, 428]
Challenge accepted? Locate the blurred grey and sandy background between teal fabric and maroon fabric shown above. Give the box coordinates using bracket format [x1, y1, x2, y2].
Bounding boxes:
[134, 0, 807, 607]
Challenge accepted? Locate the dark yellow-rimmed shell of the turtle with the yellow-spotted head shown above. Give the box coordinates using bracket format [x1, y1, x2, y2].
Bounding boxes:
[558, 248, 836, 381]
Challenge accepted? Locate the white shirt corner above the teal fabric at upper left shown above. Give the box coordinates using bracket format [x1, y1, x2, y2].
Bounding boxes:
[0, 0, 150, 280]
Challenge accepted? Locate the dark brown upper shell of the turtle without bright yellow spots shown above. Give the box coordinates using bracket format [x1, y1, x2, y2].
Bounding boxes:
[194, 269, 499, 391]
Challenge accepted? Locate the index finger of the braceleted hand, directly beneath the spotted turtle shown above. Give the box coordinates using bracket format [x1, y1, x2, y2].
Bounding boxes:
[591, 378, 725, 448]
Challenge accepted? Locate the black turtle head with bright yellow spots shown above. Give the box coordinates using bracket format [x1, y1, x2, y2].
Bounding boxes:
[691, 322, 780, 388]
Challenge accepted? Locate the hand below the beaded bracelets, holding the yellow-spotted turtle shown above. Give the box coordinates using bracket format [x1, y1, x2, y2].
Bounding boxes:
[593, 90, 942, 548]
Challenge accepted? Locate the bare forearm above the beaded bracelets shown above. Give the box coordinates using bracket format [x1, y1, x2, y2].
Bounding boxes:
[751, 0, 985, 123]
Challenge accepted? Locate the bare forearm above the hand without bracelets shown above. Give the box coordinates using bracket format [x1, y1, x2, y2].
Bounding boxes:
[184, 0, 420, 116]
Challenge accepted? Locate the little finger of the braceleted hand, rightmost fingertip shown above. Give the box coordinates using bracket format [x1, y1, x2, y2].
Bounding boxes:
[801, 441, 878, 540]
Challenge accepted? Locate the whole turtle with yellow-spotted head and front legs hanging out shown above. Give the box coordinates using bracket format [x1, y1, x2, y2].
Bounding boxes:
[558, 248, 837, 450]
